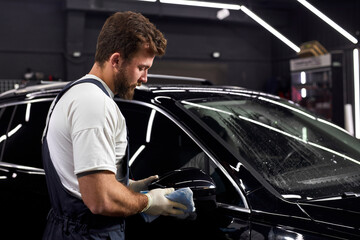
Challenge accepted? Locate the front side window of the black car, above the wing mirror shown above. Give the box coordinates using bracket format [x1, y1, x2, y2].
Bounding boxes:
[120, 101, 243, 206]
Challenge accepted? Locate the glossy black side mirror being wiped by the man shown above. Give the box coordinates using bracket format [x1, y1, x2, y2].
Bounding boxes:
[149, 168, 216, 208]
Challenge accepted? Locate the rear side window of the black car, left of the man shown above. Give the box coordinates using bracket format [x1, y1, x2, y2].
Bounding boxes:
[2, 102, 51, 168]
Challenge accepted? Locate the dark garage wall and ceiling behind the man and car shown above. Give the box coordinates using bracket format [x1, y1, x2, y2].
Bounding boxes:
[0, 0, 360, 131]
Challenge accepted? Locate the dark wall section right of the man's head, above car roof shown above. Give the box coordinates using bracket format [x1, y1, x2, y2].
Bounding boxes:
[148, 19, 271, 89]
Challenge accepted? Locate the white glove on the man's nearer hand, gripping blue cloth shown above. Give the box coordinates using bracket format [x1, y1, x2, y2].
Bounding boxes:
[143, 188, 187, 216]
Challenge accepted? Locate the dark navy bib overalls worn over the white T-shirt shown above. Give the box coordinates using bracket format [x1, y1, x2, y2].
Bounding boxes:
[42, 79, 129, 240]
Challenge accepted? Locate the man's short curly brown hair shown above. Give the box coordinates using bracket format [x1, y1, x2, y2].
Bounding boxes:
[95, 11, 167, 66]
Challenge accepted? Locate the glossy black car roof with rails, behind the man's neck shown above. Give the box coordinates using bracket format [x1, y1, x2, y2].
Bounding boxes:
[0, 74, 279, 104]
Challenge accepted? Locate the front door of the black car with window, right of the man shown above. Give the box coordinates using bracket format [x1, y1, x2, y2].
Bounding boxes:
[119, 102, 250, 239]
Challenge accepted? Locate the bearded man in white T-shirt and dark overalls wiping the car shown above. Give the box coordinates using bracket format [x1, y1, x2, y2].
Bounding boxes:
[43, 12, 186, 239]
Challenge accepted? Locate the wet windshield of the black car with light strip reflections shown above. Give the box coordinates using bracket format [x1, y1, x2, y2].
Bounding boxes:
[181, 94, 360, 200]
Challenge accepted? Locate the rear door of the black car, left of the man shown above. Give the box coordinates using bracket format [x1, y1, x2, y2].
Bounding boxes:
[0, 101, 51, 239]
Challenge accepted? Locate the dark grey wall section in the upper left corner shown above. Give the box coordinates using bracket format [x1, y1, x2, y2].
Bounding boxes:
[0, 0, 65, 79]
